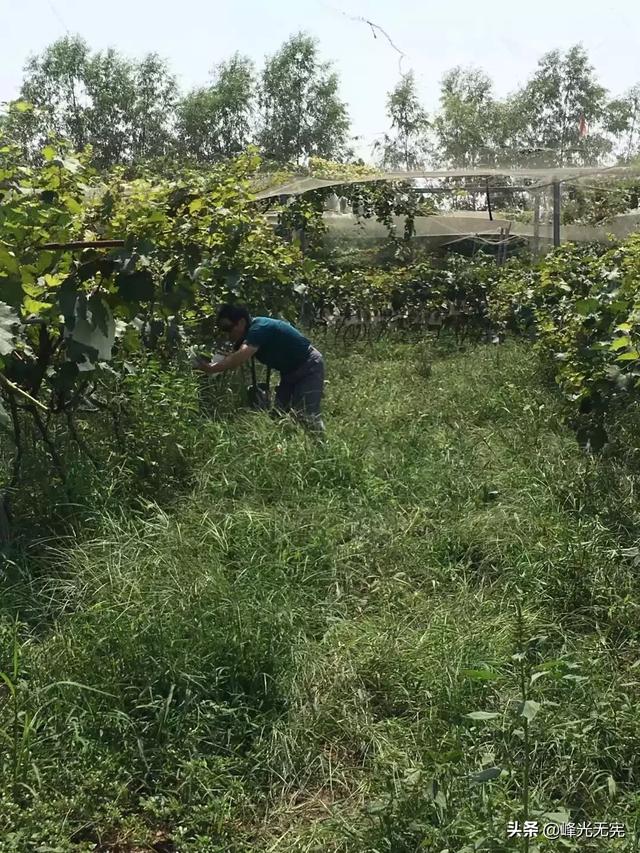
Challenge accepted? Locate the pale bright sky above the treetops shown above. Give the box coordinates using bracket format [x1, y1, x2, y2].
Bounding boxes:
[0, 0, 640, 160]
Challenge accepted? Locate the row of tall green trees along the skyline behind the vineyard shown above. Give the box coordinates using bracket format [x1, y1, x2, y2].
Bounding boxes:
[0, 33, 640, 169]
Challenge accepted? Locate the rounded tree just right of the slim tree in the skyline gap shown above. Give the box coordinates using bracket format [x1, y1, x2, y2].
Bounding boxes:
[434, 67, 501, 168]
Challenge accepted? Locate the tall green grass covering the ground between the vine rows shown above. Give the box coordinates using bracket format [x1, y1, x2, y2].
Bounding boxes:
[0, 336, 640, 853]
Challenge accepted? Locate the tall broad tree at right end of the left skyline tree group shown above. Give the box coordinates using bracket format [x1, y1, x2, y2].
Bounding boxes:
[259, 33, 349, 164]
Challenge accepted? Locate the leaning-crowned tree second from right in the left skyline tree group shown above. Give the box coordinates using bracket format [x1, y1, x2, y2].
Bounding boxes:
[176, 54, 256, 162]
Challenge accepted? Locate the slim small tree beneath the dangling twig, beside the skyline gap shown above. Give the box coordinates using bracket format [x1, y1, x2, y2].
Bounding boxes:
[376, 71, 429, 170]
